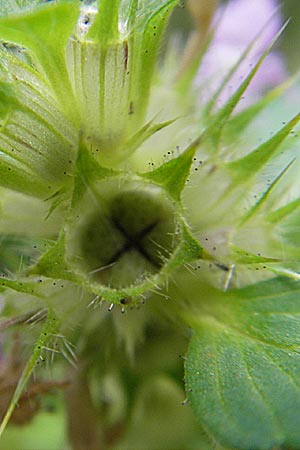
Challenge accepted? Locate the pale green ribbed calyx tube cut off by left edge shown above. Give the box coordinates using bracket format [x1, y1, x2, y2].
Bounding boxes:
[0, 46, 77, 192]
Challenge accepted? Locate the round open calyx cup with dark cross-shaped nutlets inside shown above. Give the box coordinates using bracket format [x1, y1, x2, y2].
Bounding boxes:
[66, 179, 179, 289]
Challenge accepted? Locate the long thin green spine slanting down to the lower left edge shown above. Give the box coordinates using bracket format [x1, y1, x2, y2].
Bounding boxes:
[0, 310, 59, 436]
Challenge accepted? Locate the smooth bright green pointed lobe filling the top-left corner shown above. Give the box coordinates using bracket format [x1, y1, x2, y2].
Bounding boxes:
[0, 2, 79, 119]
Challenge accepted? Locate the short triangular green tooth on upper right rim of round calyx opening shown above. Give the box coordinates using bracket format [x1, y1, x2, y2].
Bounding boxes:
[140, 139, 200, 201]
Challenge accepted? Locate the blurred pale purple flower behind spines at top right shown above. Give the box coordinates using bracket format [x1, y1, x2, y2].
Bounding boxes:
[198, 0, 288, 106]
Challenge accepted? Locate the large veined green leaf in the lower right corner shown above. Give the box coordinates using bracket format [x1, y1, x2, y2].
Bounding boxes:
[185, 278, 300, 450]
